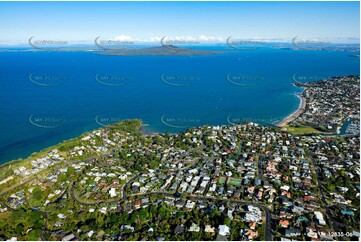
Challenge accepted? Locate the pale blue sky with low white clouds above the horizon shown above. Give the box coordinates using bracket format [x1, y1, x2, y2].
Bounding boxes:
[0, 2, 360, 45]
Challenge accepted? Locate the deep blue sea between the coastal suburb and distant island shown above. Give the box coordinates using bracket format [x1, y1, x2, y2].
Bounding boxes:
[0, 48, 360, 164]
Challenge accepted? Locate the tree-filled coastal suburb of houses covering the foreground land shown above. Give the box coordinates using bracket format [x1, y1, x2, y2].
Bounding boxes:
[0, 76, 360, 241]
